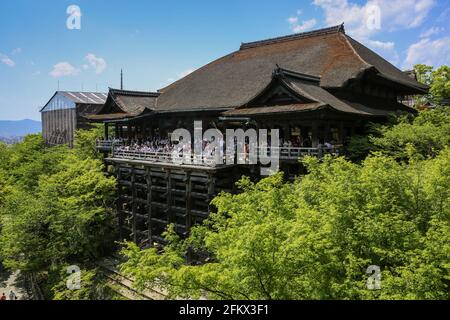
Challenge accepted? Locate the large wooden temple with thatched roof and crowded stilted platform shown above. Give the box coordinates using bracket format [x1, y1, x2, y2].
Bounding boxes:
[82, 25, 428, 246]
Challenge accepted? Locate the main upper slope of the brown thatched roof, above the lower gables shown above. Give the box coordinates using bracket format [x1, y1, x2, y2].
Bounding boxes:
[157, 26, 427, 112]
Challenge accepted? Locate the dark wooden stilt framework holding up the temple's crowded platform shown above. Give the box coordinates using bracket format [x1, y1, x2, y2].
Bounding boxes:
[115, 162, 238, 247]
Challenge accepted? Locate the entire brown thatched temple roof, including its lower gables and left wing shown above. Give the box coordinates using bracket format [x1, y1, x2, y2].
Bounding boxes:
[87, 25, 428, 120]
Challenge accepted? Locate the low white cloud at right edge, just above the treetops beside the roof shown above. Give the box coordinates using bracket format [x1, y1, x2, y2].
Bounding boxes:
[403, 37, 450, 69]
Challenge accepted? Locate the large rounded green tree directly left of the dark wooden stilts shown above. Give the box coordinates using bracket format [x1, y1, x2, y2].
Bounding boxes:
[0, 153, 115, 271]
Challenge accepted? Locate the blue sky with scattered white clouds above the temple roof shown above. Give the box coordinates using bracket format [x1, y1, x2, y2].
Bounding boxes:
[0, 0, 450, 120]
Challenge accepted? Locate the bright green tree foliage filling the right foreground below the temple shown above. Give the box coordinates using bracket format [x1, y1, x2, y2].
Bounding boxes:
[122, 108, 450, 299]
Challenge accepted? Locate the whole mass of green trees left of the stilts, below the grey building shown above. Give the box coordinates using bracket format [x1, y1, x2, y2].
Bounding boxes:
[0, 131, 116, 298]
